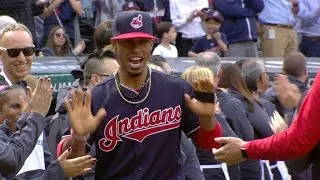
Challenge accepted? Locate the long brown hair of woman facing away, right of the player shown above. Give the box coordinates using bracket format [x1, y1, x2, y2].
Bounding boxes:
[219, 63, 255, 112]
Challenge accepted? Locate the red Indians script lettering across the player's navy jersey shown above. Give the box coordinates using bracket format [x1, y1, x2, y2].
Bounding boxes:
[98, 105, 182, 152]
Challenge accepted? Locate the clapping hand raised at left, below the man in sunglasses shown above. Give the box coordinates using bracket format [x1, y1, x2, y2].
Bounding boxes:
[26, 77, 53, 116]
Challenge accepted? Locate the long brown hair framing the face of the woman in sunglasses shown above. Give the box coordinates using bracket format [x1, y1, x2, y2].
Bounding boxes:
[47, 26, 71, 56]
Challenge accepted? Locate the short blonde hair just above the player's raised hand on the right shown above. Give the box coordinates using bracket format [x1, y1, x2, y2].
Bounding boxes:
[181, 66, 214, 84]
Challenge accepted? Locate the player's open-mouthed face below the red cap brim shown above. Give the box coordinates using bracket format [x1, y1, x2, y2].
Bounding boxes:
[114, 38, 153, 77]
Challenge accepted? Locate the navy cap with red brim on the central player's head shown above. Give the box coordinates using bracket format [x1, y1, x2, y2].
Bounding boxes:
[111, 11, 157, 40]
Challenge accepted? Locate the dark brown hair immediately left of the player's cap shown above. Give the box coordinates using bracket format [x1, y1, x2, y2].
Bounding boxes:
[93, 21, 112, 50]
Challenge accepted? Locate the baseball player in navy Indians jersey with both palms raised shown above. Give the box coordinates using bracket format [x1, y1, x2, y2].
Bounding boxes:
[60, 11, 222, 180]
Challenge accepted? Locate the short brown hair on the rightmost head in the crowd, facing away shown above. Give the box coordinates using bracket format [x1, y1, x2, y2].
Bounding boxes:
[283, 52, 307, 77]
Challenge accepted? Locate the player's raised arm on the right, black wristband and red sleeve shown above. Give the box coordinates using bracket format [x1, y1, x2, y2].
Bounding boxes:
[184, 79, 222, 149]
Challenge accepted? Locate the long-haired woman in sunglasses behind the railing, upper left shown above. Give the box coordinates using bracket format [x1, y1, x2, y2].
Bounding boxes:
[41, 26, 85, 56]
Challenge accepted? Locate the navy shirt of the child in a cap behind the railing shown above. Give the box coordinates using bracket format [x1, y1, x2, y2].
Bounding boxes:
[191, 33, 228, 54]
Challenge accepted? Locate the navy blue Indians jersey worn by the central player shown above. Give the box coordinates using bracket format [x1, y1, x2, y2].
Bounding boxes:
[92, 71, 199, 180]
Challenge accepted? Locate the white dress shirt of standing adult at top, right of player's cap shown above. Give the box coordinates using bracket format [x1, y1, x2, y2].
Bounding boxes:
[170, 0, 209, 39]
